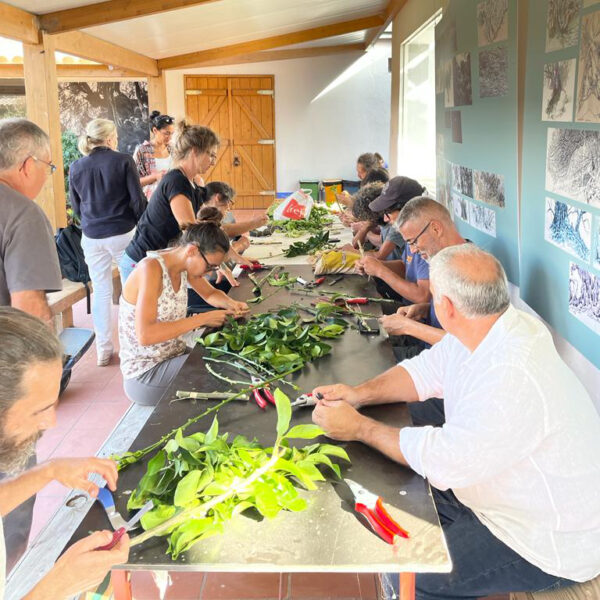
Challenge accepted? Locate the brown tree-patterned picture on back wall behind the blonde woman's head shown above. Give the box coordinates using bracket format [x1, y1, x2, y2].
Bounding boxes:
[58, 81, 149, 154]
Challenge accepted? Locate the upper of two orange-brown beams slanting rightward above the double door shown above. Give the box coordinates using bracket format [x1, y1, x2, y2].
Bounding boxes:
[158, 15, 384, 70]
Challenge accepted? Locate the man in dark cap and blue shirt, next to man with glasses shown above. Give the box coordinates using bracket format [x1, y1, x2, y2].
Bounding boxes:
[356, 176, 430, 303]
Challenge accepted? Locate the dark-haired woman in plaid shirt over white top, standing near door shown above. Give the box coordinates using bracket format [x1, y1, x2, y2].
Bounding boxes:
[133, 110, 175, 198]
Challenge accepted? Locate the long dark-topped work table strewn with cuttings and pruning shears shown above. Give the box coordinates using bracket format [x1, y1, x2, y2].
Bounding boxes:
[65, 266, 451, 597]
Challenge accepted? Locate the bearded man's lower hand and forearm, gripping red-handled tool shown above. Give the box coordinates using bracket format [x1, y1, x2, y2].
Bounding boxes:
[26, 531, 129, 600]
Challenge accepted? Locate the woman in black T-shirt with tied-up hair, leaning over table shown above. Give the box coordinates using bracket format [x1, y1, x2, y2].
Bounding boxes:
[119, 121, 219, 281]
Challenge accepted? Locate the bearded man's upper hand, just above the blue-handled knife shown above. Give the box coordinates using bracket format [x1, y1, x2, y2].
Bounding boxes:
[47, 457, 119, 498]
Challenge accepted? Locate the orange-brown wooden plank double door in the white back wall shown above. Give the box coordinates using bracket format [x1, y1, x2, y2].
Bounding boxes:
[185, 75, 277, 209]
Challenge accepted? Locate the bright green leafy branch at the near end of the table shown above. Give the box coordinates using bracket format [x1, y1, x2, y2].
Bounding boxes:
[128, 390, 349, 559]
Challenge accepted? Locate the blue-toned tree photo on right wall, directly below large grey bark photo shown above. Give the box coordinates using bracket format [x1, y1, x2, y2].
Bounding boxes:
[544, 198, 592, 262]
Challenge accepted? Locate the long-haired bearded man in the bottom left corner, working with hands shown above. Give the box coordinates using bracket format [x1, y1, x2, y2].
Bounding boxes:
[0, 307, 129, 600]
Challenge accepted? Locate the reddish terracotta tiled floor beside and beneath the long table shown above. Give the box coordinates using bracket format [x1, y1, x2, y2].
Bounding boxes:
[32, 224, 508, 600]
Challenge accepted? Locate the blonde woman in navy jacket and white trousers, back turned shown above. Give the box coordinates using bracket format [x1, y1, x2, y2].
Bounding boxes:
[69, 119, 146, 367]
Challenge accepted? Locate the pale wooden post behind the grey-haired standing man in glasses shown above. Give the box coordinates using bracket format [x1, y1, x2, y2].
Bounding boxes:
[23, 33, 67, 228]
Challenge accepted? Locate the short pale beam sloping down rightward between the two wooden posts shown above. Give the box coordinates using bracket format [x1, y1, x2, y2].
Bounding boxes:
[52, 31, 159, 77]
